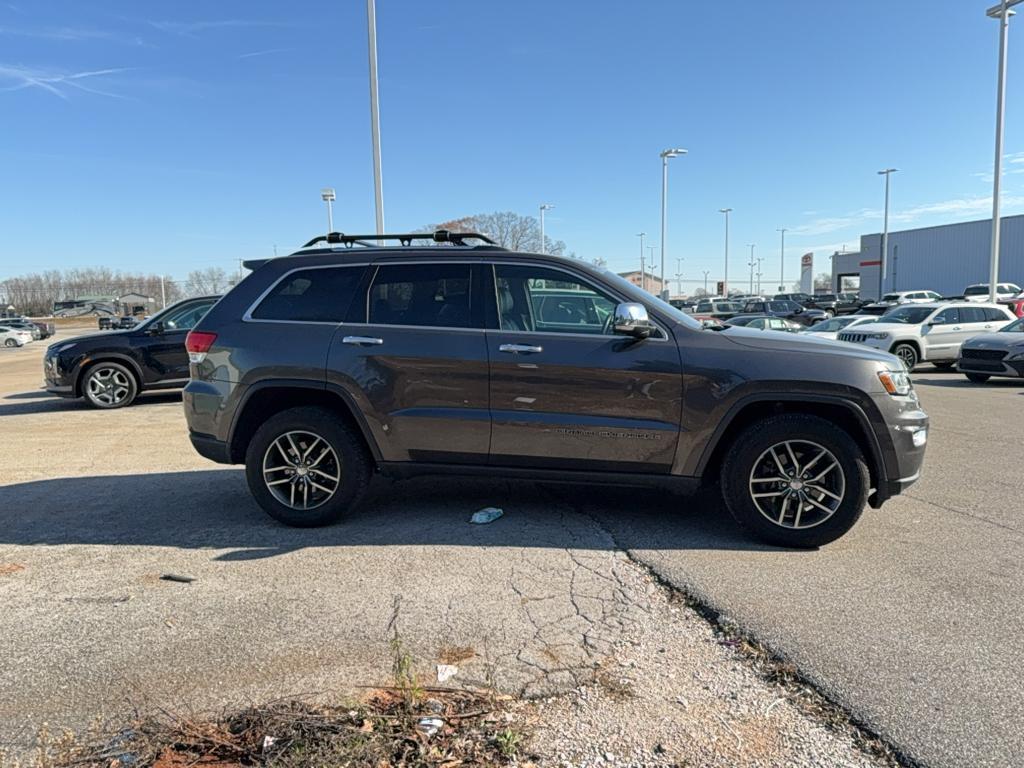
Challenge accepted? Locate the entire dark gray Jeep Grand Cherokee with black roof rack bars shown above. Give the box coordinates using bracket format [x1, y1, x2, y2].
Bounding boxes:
[184, 231, 928, 546]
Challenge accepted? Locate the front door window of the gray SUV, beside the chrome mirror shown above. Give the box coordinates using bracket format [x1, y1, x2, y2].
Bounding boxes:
[495, 264, 616, 334]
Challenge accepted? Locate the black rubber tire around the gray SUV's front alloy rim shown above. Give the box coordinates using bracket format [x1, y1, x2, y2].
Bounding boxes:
[720, 414, 870, 548]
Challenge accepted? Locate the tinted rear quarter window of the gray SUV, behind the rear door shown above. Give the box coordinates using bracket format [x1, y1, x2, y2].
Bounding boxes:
[252, 266, 366, 323]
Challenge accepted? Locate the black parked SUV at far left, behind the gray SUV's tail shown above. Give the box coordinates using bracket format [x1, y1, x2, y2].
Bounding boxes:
[43, 296, 220, 408]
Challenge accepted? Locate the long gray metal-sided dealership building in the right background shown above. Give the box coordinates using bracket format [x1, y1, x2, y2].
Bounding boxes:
[831, 215, 1024, 298]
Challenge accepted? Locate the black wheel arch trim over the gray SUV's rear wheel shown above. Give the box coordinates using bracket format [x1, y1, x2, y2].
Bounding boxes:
[227, 380, 381, 464]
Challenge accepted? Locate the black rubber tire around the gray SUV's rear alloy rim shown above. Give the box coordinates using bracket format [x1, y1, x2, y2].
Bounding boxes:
[246, 407, 371, 527]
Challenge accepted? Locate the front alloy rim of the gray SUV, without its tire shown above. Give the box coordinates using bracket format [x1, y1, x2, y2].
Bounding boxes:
[749, 440, 846, 529]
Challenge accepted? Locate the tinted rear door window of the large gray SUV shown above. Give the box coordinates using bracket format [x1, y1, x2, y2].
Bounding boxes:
[370, 264, 473, 328]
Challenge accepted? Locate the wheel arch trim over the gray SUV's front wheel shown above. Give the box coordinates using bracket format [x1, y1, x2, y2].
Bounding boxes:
[696, 393, 886, 488]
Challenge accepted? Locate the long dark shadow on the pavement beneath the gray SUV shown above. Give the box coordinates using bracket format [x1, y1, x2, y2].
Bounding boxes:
[0, 469, 776, 561]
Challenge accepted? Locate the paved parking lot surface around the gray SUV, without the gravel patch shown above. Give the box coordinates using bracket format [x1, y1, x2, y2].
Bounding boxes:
[0, 331, 1024, 766]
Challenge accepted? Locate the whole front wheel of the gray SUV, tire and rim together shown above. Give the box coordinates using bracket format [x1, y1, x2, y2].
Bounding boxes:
[721, 414, 870, 547]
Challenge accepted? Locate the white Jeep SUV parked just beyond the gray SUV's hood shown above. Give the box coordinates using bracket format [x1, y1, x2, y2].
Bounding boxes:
[839, 301, 1016, 371]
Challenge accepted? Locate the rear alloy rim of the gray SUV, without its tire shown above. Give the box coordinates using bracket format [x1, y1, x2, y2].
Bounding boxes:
[262, 430, 341, 509]
